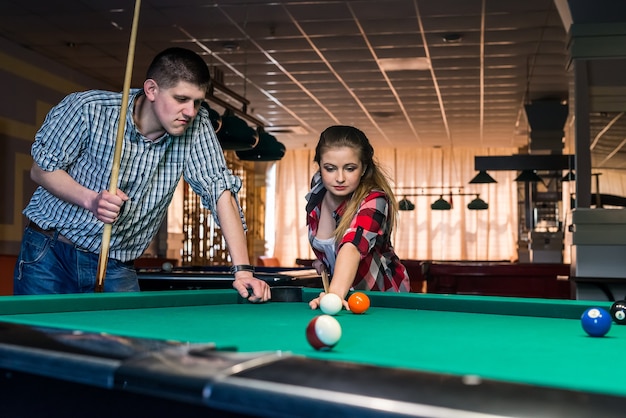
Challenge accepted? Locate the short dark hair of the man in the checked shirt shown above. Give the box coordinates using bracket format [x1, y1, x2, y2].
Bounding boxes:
[146, 47, 211, 89]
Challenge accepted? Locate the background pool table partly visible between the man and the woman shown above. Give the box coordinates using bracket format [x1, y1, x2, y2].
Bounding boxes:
[137, 266, 322, 291]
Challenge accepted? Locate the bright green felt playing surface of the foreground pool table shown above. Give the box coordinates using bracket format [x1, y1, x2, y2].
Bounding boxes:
[0, 290, 626, 396]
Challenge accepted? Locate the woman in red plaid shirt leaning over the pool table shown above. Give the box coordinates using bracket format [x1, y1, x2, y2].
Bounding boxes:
[306, 126, 410, 309]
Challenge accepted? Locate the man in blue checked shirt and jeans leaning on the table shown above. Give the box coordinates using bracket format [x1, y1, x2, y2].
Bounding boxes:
[14, 48, 270, 302]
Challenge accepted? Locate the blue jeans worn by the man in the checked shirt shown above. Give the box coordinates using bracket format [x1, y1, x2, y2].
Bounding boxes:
[13, 227, 139, 295]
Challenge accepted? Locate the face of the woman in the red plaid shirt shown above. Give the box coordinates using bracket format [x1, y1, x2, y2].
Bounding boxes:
[320, 147, 364, 198]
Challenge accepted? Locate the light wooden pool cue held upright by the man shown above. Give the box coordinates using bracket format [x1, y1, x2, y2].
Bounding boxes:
[95, 0, 141, 293]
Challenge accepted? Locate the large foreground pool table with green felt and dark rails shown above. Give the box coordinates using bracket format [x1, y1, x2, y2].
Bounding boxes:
[0, 287, 626, 418]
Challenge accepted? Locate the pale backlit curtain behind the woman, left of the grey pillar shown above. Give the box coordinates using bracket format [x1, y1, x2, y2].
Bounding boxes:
[274, 148, 518, 266]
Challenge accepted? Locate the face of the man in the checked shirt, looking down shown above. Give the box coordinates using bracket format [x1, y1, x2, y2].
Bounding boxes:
[153, 81, 206, 136]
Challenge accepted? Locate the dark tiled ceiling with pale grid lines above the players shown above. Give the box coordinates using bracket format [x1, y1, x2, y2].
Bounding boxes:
[0, 0, 626, 168]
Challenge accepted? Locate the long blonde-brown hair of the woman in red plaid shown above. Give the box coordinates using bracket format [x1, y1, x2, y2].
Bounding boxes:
[314, 125, 398, 240]
